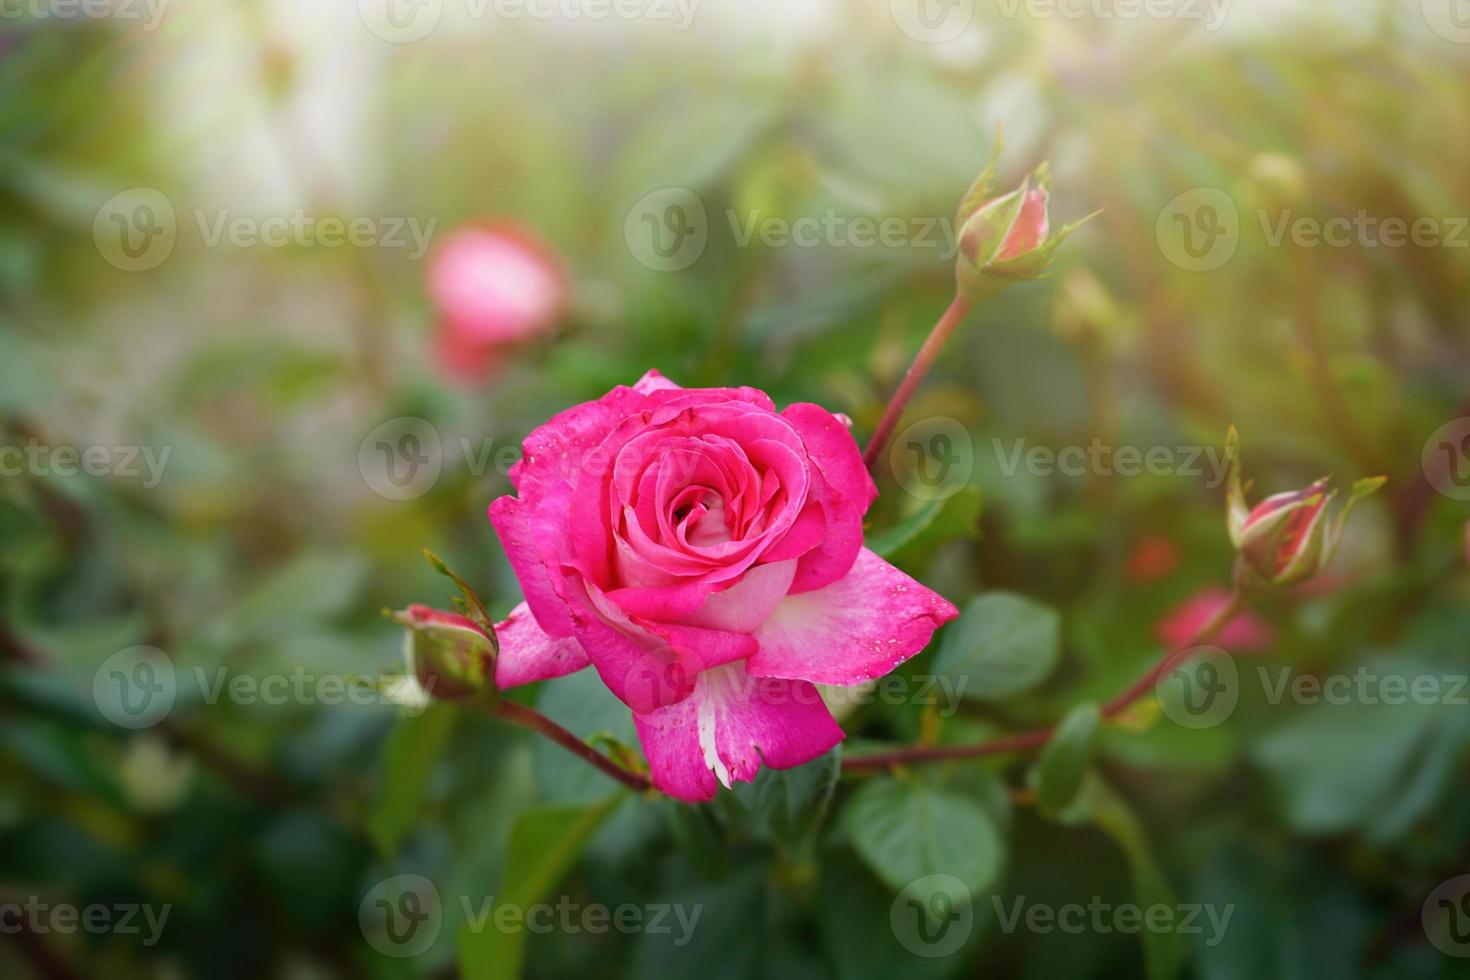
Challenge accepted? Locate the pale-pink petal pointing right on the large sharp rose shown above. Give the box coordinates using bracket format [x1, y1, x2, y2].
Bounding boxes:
[747, 548, 960, 685]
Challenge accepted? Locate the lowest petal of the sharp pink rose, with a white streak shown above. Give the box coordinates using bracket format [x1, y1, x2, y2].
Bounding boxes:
[634, 664, 842, 802]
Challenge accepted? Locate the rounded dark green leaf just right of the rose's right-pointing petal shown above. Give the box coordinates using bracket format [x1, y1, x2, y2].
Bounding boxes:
[935, 592, 1061, 701]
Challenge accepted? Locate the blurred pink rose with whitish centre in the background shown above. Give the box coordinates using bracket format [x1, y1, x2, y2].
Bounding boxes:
[428, 222, 567, 379]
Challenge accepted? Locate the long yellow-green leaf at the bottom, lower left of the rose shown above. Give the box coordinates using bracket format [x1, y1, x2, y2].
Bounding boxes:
[459, 795, 622, 980]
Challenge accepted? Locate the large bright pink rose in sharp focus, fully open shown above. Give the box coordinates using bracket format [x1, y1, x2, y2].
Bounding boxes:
[490, 372, 957, 801]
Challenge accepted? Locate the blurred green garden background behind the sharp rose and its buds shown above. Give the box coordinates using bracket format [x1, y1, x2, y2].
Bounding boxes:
[0, 0, 1470, 980]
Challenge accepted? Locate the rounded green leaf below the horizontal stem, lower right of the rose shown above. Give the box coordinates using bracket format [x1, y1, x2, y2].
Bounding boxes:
[844, 777, 1005, 901]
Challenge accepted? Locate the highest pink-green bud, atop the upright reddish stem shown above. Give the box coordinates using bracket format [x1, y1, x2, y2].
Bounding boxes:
[956, 160, 1092, 304]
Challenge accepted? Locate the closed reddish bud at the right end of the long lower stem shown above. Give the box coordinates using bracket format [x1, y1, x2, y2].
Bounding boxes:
[1225, 426, 1385, 585]
